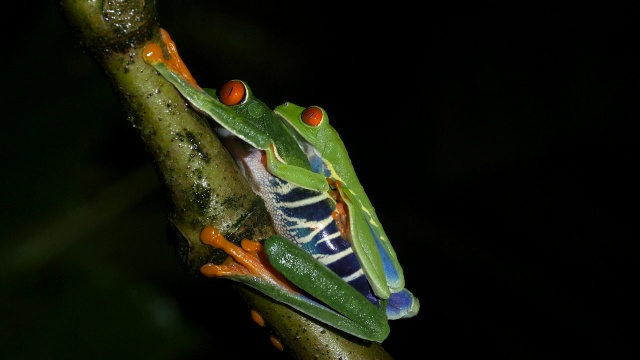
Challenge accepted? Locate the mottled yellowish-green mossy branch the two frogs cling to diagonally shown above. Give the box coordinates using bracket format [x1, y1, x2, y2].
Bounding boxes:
[60, 0, 390, 359]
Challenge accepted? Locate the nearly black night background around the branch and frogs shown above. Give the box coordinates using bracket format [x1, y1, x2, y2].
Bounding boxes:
[0, 0, 639, 360]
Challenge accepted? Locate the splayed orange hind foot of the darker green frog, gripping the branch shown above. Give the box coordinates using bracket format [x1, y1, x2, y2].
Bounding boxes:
[200, 226, 300, 293]
